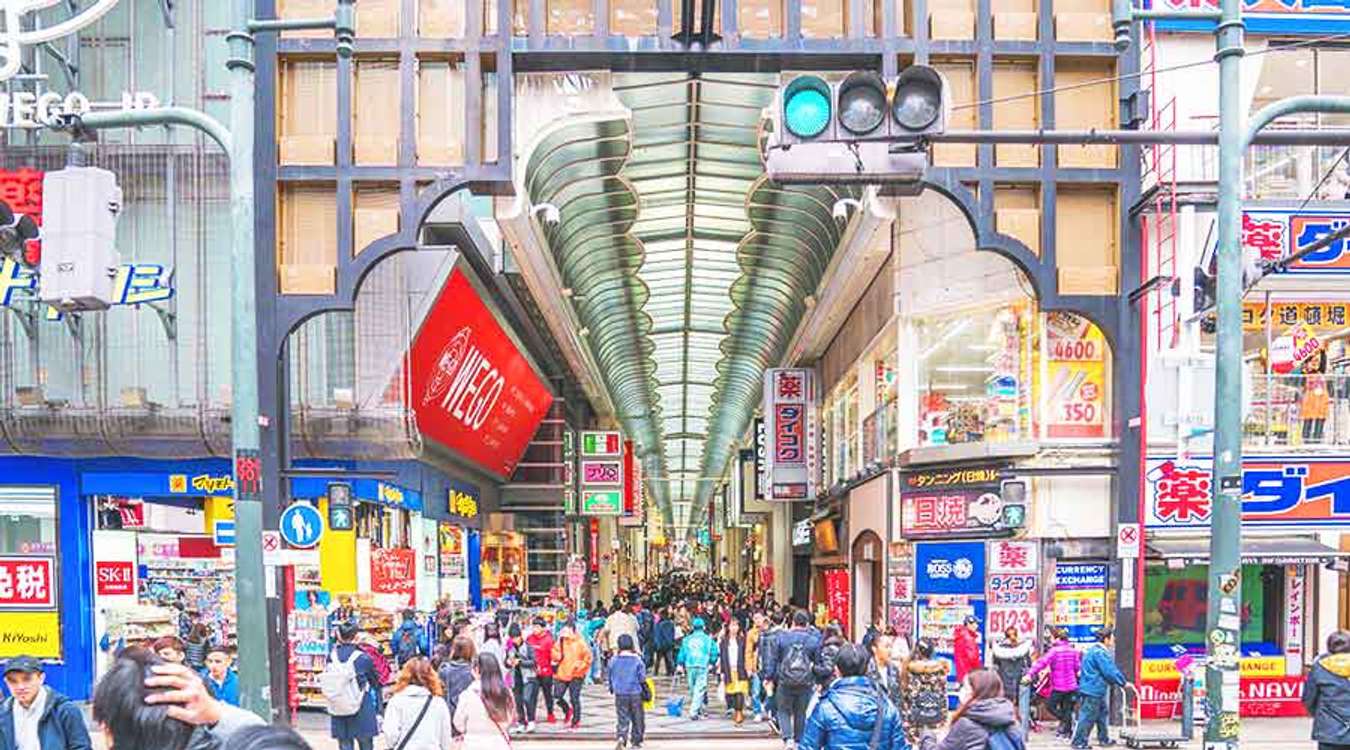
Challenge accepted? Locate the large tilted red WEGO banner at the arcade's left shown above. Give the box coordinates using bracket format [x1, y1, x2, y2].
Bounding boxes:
[409, 268, 554, 478]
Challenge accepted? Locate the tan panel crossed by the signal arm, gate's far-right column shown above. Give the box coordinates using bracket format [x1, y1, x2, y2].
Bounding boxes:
[1054, 61, 1116, 169]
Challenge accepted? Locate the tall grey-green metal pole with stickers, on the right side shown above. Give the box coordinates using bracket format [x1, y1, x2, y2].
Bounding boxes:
[1204, 0, 1246, 750]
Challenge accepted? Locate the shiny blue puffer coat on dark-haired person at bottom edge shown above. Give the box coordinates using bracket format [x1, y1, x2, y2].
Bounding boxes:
[798, 677, 909, 750]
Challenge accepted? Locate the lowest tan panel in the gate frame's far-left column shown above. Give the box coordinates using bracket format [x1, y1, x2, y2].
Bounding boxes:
[277, 185, 338, 294]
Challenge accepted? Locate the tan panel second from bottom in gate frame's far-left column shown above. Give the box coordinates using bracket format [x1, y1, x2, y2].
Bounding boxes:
[277, 58, 338, 166]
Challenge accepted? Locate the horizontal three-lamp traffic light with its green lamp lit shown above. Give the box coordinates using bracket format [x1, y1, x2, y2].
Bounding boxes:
[764, 65, 950, 187]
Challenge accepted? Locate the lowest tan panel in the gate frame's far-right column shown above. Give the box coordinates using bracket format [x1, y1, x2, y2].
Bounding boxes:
[1054, 185, 1121, 294]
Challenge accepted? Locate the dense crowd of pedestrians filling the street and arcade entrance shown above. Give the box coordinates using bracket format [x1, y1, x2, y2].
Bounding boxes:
[0, 575, 1350, 750]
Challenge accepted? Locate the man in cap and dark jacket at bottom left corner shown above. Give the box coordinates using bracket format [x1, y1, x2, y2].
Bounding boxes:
[0, 657, 93, 750]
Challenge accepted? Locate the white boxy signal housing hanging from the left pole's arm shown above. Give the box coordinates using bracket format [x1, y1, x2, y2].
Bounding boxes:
[38, 167, 122, 312]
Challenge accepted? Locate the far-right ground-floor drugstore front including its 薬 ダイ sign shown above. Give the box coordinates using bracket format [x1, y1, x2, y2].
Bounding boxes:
[1142, 456, 1350, 716]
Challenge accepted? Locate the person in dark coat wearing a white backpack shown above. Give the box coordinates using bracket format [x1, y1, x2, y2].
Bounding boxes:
[326, 622, 379, 750]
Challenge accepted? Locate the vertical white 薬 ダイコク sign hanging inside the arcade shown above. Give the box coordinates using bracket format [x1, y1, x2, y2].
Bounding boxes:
[764, 368, 819, 500]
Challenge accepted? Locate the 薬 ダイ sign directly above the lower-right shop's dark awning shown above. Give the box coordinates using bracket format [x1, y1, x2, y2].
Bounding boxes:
[1145, 456, 1350, 529]
